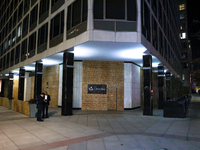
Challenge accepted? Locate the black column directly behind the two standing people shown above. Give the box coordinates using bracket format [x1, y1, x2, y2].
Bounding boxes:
[34, 61, 43, 99]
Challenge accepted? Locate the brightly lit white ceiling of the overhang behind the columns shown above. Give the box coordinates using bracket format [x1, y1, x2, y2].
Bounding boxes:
[11, 41, 160, 73]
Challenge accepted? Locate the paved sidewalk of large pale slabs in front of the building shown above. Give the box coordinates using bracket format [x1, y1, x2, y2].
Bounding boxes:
[0, 95, 200, 150]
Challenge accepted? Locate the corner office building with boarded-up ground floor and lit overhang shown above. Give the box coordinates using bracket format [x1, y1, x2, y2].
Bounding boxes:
[0, 0, 183, 114]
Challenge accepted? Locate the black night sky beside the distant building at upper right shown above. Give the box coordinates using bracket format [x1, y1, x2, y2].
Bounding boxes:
[187, 0, 200, 59]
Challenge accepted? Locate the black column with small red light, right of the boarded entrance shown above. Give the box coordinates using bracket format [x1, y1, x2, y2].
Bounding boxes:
[143, 55, 153, 115]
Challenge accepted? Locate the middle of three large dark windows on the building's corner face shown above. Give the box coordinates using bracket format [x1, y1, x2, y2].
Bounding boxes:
[106, 0, 125, 19]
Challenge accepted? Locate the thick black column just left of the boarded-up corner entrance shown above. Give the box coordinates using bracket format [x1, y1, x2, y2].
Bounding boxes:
[62, 51, 74, 116]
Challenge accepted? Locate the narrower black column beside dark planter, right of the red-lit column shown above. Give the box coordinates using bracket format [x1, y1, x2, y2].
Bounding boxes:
[158, 66, 165, 109]
